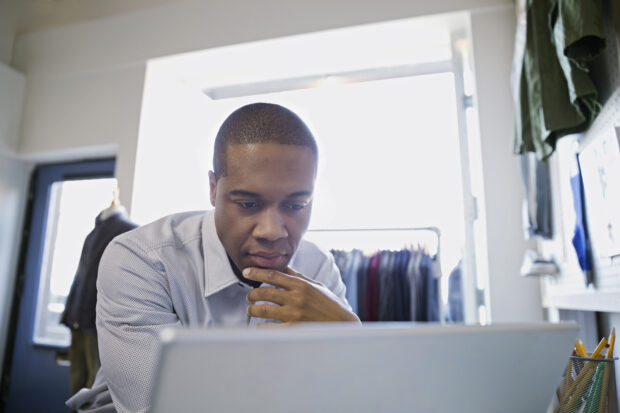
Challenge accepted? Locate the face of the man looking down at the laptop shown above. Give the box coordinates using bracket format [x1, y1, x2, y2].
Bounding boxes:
[209, 143, 316, 271]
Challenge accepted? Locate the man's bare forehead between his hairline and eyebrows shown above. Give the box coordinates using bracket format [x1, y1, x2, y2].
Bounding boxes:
[221, 143, 316, 193]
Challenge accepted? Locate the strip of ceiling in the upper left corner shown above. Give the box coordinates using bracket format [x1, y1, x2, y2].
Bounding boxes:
[7, 0, 183, 35]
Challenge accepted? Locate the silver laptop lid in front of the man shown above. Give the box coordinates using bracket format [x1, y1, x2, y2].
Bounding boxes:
[152, 323, 579, 413]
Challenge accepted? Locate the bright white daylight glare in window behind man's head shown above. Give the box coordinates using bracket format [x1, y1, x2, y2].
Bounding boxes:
[133, 73, 464, 274]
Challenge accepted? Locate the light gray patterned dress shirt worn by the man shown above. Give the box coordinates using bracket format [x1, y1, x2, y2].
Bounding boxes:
[67, 211, 350, 412]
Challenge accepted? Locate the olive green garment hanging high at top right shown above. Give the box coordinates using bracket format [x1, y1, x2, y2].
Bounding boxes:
[513, 0, 605, 160]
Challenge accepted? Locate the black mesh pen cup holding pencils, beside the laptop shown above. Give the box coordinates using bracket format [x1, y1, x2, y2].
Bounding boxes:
[554, 356, 618, 413]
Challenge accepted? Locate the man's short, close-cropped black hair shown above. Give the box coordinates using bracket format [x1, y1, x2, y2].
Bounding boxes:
[213, 103, 319, 179]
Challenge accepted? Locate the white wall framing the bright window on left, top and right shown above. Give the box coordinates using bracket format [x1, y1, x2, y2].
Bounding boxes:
[6, 0, 542, 328]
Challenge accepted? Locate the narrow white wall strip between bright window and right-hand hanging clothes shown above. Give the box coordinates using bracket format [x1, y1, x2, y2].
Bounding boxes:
[471, 9, 543, 323]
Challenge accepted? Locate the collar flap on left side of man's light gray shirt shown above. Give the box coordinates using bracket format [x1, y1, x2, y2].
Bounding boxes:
[202, 210, 245, 297]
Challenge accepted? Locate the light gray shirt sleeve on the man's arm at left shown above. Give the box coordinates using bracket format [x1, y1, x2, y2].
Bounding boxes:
[97, 239, 180, 412]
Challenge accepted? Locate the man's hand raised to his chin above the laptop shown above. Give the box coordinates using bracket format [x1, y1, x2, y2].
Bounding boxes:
[243, 267, 360, 323]
